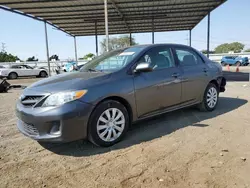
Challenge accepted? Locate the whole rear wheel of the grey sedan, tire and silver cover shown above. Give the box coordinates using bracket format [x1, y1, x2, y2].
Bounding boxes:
[199, 83, 219, 112]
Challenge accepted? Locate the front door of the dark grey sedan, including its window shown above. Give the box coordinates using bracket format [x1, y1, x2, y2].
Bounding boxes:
[134, 46, 181, 117]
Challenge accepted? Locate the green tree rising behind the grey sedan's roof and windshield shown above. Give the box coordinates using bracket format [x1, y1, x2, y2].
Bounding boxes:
[101, 35, 137, 52]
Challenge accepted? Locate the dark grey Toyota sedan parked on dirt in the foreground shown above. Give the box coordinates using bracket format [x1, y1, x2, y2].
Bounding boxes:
[16, 44, 226, 146]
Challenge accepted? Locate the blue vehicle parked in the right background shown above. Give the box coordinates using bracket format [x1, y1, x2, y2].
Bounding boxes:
[221, 56, 249, 66]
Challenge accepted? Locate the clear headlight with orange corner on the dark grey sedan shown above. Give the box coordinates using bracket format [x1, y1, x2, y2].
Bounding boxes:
[42, 90, 87, 107]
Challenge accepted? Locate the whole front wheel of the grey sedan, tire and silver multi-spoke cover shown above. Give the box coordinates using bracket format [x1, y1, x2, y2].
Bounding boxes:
[88, 100, 130, 147]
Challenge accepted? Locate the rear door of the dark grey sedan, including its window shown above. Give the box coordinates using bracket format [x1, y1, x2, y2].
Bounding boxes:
[175, 47, 209, 103]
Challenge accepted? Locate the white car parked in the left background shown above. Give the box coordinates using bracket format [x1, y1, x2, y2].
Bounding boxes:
[0, 65, 48, 79]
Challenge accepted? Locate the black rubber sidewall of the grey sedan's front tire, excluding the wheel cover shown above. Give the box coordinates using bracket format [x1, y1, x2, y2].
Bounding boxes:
[88, 100, 130, 147]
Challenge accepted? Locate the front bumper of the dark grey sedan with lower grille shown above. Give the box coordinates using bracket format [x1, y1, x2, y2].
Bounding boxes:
[16, 100, 93, 142]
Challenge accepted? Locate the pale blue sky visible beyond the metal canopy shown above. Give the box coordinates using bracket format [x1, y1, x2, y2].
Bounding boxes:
[0, 0, 250, 60]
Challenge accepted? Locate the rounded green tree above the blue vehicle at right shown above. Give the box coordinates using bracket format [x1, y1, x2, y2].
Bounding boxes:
[215, 42, 245, 53]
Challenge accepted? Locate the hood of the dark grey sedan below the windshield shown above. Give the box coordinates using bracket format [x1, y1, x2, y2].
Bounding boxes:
[26, 72, 111, 93]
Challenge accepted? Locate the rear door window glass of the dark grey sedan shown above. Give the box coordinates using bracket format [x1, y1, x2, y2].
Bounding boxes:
[176, 48, 203, 66]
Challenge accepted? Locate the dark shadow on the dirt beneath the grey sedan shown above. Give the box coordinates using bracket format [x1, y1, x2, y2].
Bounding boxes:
[40, 97, 248, 157]
